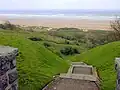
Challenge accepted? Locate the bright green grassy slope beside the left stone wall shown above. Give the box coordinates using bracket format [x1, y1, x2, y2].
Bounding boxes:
[0, 31, 68, 90]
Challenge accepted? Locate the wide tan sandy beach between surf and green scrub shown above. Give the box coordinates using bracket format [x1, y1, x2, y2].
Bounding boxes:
[0, 16, 111, 30]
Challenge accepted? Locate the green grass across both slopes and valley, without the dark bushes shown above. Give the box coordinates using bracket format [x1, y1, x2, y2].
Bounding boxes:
[0, 30, 116, 90]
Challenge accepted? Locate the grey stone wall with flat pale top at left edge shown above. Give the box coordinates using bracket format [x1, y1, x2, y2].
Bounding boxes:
[0, 46, 18, 90]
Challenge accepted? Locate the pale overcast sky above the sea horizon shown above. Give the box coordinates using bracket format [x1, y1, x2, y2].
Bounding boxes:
[0, 0, 120, 10]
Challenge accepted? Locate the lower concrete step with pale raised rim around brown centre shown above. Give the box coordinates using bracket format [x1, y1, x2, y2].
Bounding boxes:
[60, 62, 98, 81]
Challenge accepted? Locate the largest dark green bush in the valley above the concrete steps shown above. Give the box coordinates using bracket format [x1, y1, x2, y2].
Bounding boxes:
[60, 47, 80, 55]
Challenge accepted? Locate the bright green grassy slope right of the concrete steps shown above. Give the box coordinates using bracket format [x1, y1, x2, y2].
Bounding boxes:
[73, 42, 120, 90]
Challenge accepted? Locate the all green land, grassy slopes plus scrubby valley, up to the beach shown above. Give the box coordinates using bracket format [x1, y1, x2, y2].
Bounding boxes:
[0, 24, 117, 90]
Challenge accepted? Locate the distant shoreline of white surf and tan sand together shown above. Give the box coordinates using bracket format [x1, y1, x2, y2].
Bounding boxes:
[0, 12, 116, 30]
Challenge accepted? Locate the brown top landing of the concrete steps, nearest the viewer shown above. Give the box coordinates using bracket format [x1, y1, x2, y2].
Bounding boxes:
[44, 78, 99, 90]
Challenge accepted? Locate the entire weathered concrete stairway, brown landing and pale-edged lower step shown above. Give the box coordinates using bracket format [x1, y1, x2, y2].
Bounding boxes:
[43, 62, 100, 90]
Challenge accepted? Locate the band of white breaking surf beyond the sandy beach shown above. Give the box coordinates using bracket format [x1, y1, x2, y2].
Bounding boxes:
[0, 13, 119, 20]
